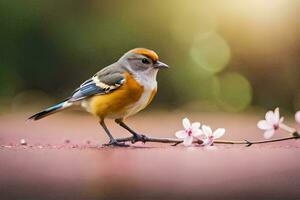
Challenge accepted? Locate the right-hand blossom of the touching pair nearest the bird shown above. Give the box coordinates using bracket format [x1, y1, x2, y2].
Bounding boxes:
[201, 125, 225, 146]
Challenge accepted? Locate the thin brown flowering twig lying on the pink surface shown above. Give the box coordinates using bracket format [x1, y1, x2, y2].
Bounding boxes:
[117, 132, 300, 147]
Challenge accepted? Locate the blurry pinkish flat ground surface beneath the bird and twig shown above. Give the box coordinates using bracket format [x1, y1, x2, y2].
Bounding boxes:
[0, 113, 300, 199]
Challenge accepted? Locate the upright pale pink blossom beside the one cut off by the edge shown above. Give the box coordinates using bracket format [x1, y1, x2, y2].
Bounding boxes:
[257, 108, 284, 139]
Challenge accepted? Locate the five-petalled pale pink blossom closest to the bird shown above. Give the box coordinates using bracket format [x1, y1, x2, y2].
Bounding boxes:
[175, 118, 203, 146]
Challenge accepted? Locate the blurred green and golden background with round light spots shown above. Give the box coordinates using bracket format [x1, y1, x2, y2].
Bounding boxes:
[0, 0, 300, 112]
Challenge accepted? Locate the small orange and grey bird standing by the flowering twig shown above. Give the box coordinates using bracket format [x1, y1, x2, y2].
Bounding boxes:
[29, 48, 169, 146]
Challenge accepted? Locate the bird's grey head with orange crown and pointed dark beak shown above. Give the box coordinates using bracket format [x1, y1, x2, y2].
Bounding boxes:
[119, 48, 169, 72]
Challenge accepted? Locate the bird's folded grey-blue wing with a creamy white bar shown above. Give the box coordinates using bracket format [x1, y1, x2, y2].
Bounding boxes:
[69, 64, 125, 102]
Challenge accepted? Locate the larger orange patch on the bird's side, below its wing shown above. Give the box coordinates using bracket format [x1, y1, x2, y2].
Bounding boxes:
[89, 73, 144, 118]
